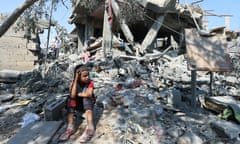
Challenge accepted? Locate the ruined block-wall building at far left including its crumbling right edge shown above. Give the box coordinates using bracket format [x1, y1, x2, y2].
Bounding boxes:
[0, 13, 56, 71]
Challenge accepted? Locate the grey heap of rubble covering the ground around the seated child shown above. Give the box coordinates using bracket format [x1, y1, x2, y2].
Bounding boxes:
[0, 50, 240, 144]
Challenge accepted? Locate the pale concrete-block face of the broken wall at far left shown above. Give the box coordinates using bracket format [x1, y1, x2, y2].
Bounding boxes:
[0, 14, 37, 71]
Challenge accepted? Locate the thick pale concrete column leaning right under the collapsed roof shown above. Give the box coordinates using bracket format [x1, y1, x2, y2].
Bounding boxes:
[140, 15, 165, 53]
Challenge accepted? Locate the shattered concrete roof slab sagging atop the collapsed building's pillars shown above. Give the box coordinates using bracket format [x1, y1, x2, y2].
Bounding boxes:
[68, 0, 202, 29]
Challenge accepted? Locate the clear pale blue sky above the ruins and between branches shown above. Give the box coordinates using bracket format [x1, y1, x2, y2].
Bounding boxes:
[0, 0, 240, 44]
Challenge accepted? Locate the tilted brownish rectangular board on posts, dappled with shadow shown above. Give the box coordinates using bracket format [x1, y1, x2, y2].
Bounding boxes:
[185, 29, 233, 71]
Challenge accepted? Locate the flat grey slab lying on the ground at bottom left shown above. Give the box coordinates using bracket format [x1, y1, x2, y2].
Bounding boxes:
[7, 121, 62, 144]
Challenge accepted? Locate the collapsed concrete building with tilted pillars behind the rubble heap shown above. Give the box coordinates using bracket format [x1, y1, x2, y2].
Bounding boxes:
[68, 0, 203, 55]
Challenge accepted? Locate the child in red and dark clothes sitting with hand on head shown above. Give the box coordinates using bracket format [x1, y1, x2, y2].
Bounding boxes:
[59, 65, 95, 142]
